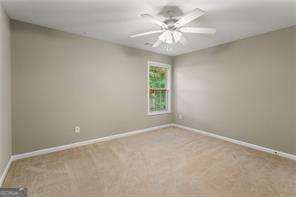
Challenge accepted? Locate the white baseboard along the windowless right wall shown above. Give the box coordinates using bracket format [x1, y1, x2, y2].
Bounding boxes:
[172, 124, 296, 160]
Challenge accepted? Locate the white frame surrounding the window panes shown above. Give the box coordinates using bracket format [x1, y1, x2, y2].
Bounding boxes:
[147, 61, 172, 116]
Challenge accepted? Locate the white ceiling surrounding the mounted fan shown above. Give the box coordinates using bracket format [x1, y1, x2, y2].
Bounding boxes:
[0, 0, 296, 56]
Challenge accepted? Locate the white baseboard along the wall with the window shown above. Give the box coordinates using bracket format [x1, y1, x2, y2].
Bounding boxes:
[12, 124, 172, 161]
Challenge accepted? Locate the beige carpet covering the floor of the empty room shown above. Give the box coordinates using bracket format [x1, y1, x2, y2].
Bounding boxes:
[4, 127, 296, 197]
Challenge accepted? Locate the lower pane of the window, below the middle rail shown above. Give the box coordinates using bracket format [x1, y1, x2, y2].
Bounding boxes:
[149, 89, 168, 112]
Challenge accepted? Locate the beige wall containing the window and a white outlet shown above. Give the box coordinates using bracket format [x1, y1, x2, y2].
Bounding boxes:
[11, 21, 172, 154]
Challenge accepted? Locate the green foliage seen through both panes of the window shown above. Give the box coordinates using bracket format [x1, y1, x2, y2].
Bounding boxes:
[149, 66, 168, 112]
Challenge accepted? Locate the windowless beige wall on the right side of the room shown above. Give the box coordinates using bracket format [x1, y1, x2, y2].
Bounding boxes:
[174, 27, 296, 154]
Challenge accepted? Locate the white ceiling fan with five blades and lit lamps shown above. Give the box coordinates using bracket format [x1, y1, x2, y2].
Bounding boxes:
[130, 8, 216, 47]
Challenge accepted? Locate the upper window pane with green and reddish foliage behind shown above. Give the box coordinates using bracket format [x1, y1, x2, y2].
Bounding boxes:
[149, 66, 168, 88]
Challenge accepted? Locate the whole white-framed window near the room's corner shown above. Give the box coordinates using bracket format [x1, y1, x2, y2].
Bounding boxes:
[148, 62, 171, 115]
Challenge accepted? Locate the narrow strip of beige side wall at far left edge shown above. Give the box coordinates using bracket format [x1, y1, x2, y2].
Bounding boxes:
[0, 4, 11, 177]
